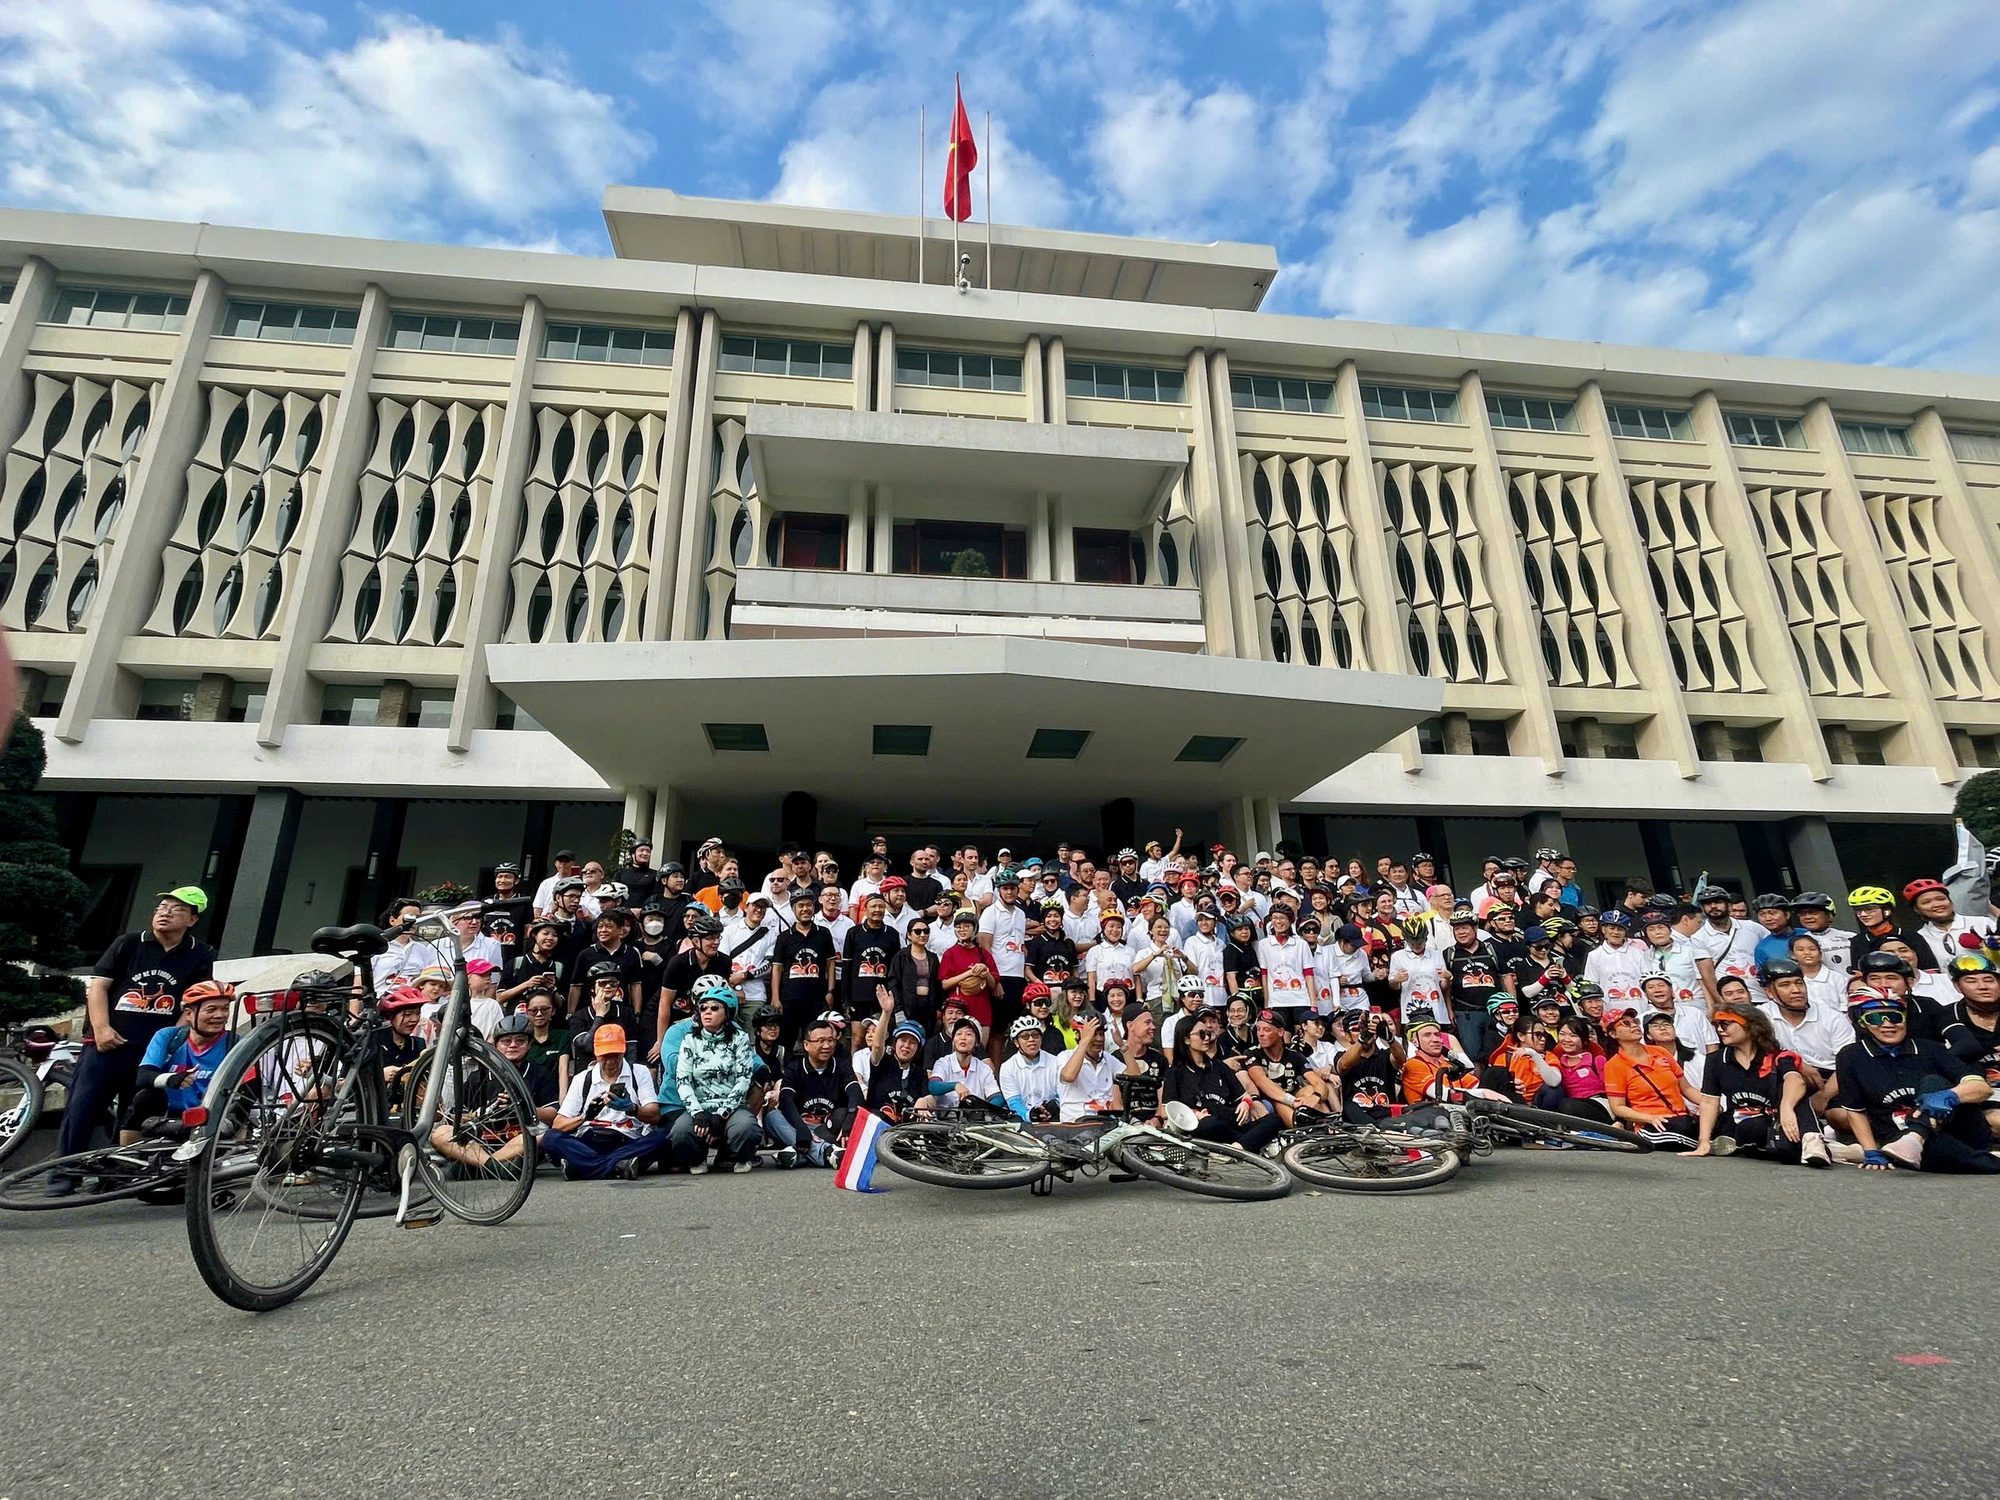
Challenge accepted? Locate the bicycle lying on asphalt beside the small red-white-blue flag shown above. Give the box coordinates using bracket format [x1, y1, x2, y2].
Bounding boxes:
[876, 1100, 1292, 1200]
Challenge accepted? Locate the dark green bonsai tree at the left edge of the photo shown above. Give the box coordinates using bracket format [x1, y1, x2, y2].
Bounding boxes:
[0, 714, 90, 1022]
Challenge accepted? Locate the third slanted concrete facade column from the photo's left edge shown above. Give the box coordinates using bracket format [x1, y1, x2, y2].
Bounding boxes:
[252, 286, 388, 750]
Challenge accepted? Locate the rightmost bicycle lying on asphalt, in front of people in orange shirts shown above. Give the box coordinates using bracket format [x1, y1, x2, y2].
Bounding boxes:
[1278, 1094, 1652, 1192]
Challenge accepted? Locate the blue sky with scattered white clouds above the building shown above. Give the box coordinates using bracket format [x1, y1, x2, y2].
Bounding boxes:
[0, 0, 2000, 370]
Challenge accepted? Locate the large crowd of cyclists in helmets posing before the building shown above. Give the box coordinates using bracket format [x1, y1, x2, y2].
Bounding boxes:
[47, 830, 2000, 1178]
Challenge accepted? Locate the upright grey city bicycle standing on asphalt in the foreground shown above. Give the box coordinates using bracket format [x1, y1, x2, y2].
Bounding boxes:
[180, 912, 538, 1312]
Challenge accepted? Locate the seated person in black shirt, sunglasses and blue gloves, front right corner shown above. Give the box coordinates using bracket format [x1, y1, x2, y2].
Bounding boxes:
[1834, 990, 2000, 1176]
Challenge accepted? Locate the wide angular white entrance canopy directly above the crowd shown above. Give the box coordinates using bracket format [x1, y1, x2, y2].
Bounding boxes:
[486, 636, 1444, 816]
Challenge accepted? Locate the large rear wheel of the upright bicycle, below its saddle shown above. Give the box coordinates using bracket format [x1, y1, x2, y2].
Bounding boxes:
[188, 1016, 382, 1312]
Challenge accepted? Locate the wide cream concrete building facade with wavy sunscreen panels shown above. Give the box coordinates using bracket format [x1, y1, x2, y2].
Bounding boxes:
[0, 188, 2000, 952]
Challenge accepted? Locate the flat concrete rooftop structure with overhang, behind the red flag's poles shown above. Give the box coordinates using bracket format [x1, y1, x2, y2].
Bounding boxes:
[604, 186, 1278, 312]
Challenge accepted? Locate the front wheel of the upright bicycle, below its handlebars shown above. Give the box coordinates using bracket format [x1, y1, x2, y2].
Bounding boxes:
[402, 1036, 538, 1224]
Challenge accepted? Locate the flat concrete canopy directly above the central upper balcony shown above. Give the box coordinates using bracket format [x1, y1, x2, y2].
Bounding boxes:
[746, 406, 1188, 528]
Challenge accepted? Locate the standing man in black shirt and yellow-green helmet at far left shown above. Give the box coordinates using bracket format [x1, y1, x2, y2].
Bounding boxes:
[48, 886, 216, 1198]
